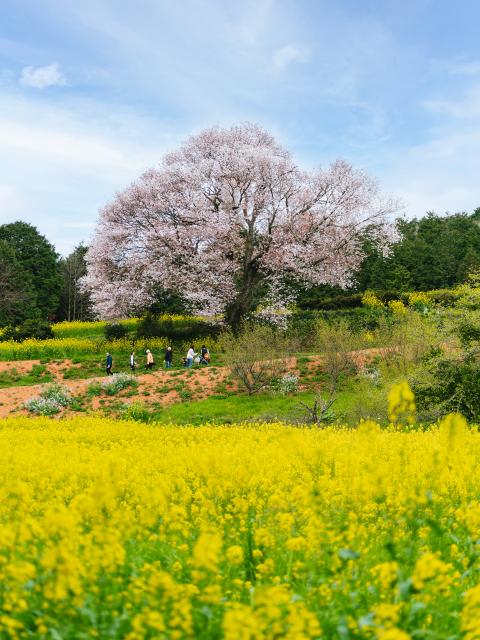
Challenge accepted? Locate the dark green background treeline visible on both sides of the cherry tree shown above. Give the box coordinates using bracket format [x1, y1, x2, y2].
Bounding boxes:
[0, 208, 480, 332]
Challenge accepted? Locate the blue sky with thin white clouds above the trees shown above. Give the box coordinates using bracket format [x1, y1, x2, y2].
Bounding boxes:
[0, 0, 480, 255]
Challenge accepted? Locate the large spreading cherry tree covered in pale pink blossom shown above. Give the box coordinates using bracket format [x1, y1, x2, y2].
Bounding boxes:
[86, 124, 396, 328]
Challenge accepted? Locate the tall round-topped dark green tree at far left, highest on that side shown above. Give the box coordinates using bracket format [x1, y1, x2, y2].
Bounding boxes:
[0, 222, 62, 318]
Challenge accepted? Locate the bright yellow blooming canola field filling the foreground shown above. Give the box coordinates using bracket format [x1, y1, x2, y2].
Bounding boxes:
[0, 416, 480, 640]
